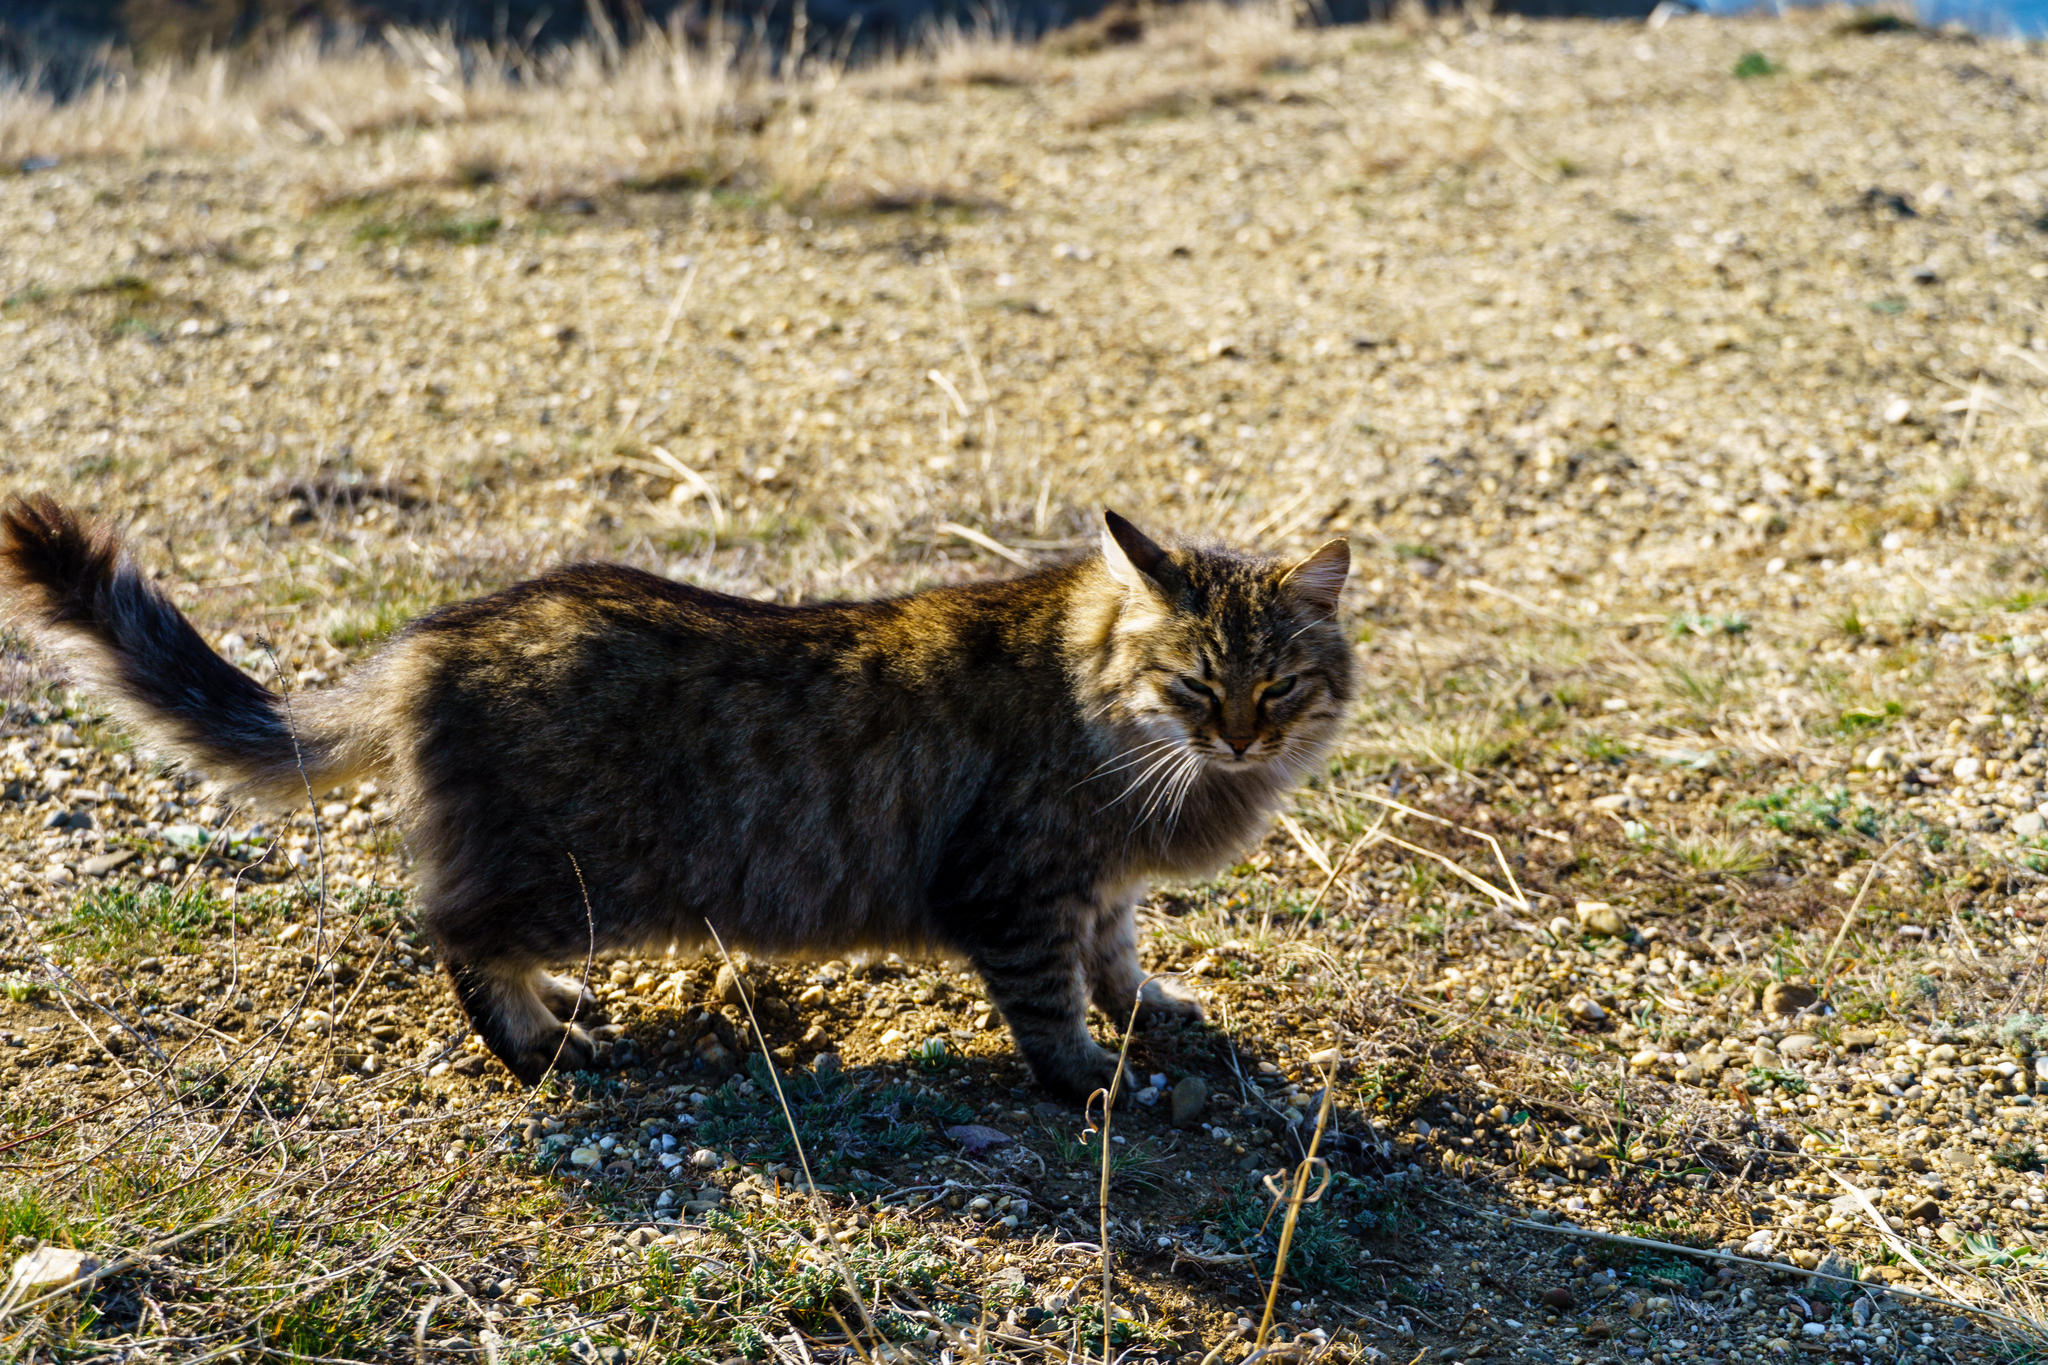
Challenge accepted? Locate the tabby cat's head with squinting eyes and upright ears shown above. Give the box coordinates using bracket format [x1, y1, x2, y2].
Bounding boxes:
[1102, 512, 1354, 778]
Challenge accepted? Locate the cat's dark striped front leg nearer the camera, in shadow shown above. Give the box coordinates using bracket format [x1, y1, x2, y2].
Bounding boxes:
[969, 911, 1116, 1101]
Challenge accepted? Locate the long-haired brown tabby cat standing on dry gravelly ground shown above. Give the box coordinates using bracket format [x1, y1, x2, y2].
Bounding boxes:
[0, 497, 1354, 1097]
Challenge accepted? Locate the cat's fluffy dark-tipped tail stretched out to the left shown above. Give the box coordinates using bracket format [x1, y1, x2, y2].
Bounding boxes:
[0, 495, 369, 804]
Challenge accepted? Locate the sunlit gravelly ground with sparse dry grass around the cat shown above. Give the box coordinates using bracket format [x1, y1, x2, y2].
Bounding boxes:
[0, 10, 2048, 1365]
